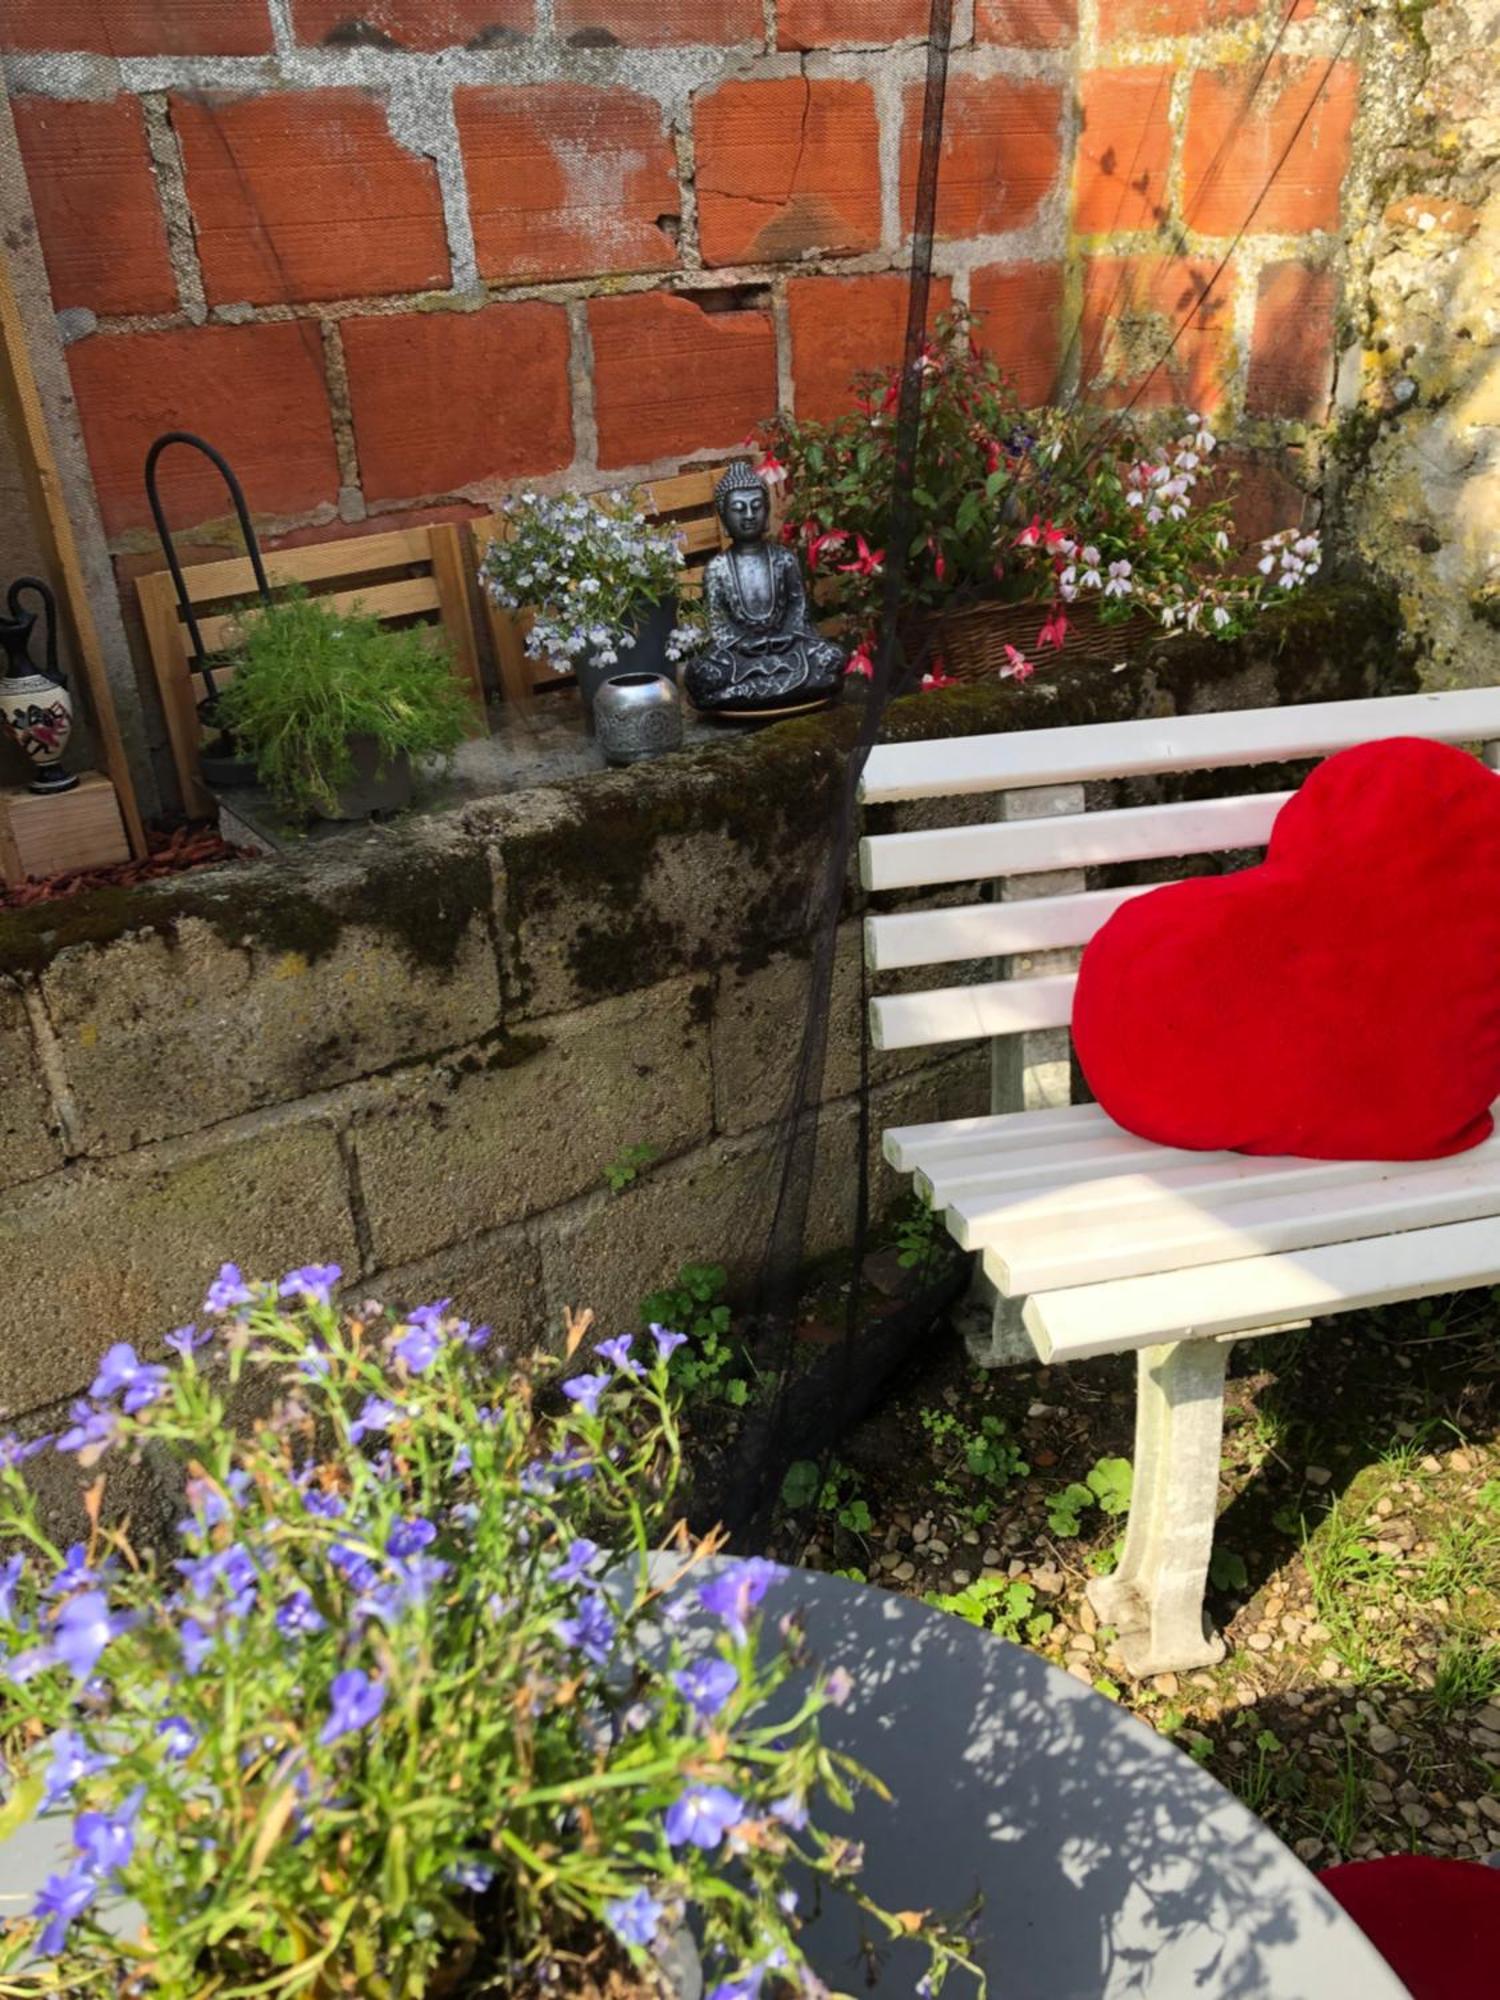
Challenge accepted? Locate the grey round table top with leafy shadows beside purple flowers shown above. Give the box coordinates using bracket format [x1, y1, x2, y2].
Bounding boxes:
[766, 1570, 1408, 2000]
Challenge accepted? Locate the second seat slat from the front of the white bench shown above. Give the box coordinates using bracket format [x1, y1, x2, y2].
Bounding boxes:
[984, 1140, 1500, 1296]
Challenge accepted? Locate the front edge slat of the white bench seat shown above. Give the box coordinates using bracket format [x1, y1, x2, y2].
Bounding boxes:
[1026, 1216, 1500, 1360]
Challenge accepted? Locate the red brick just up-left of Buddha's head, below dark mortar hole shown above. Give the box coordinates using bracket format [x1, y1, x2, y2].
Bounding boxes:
[588, 292, 776, 468]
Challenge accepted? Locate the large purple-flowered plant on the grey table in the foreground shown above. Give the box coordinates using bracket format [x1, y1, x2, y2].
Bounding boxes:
[0, 1266, 988, 2000]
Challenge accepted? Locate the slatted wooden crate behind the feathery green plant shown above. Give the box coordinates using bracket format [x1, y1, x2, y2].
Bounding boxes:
[136, 522, 488, 816]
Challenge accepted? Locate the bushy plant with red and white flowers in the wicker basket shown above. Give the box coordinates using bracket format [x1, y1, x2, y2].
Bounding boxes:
[768, 312, 1322, 686]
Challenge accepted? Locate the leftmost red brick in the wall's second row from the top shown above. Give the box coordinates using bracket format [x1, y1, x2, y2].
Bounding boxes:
[12, 96, 178, 314]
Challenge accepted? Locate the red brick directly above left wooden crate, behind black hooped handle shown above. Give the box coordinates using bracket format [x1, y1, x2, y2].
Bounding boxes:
[68, 322, 338, 534]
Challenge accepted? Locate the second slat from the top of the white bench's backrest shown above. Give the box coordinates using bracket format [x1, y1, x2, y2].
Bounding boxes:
[860, 792, 1294, 890]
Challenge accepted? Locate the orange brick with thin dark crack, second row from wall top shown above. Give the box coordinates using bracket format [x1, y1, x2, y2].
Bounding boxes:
[694, 76, 880, 264]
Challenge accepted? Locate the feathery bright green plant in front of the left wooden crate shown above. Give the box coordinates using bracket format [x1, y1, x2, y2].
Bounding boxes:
[218, 590, 472, 814]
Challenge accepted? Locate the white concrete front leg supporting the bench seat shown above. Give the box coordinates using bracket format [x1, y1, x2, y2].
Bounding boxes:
[1088, 1340, 1232, 1678]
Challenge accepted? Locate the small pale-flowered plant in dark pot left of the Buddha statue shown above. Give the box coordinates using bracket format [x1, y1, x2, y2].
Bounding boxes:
[480, 492, 682, 674]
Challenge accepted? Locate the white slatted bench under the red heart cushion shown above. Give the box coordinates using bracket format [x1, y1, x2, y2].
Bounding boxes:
[860, 688, 1500, 1674]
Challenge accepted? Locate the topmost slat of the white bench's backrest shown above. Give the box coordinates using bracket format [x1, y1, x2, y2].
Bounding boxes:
[860, 688, 1500, 806]
